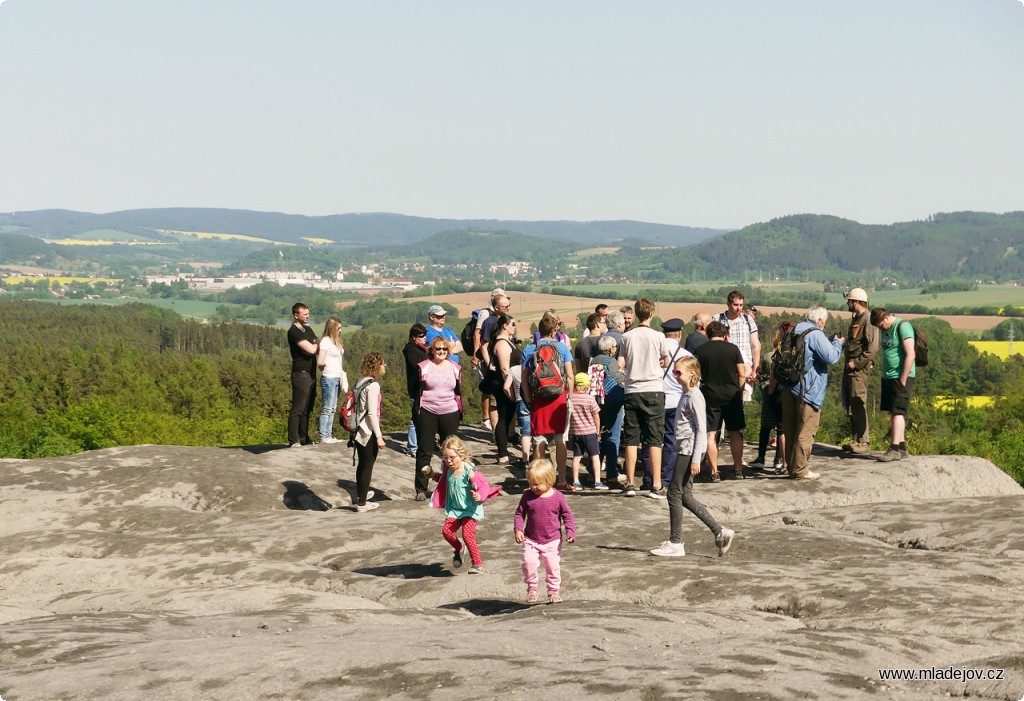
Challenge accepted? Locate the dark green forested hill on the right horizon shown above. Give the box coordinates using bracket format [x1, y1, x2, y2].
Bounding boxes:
[660, 212, 1024, 279]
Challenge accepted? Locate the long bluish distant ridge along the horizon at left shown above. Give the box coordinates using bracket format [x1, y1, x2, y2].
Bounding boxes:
[0, 208, 725, 248]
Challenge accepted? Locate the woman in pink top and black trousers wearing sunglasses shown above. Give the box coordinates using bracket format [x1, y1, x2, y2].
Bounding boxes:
[413, 336, 462, 475]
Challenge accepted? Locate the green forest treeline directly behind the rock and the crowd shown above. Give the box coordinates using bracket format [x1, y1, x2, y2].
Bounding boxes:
[0, 300, 1024, 483]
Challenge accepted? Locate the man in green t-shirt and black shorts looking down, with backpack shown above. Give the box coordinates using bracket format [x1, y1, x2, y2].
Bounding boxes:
[871, 307, 918, 463]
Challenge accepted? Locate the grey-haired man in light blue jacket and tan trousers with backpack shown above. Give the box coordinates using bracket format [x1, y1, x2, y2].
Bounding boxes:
[779, 305, 845, 480]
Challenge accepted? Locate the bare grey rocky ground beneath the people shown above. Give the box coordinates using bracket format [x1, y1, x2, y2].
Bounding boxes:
[0, 427, 1024, 701]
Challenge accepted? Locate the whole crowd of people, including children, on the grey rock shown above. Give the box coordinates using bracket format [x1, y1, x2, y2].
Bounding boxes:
[288, 288, 916, 602]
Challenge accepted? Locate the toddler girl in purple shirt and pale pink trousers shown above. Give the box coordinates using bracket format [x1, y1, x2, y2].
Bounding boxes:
[515, 459, 575, 604]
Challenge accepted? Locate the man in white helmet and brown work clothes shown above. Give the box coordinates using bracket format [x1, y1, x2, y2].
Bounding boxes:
[842, 288, 879, 454]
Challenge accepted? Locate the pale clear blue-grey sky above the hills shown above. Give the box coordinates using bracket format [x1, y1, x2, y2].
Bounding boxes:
[0, 0, 1024, 228]
